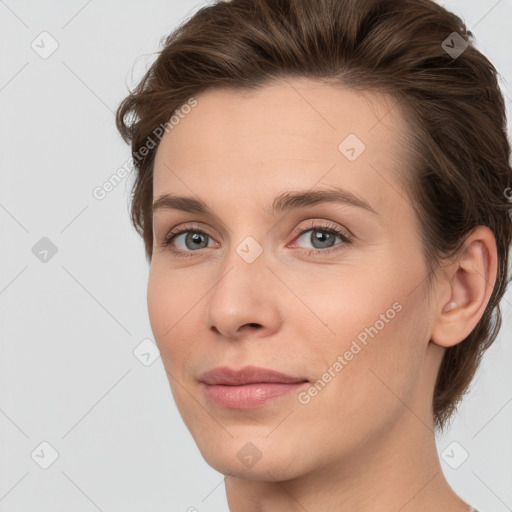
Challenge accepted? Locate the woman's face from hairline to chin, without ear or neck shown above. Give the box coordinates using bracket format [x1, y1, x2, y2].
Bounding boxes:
[148, 79, 442, 480]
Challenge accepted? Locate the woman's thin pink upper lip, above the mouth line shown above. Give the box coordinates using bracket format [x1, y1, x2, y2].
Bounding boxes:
[199, 366, 307, 386]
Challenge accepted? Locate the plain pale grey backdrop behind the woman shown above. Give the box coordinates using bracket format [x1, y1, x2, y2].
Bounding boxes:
[0, 0, 512, 512]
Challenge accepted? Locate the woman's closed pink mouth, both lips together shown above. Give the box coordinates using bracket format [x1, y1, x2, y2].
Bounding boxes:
[199, 366, 309, 409]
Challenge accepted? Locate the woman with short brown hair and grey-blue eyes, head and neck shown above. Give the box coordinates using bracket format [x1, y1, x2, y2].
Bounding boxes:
[117, 0, 512, 512]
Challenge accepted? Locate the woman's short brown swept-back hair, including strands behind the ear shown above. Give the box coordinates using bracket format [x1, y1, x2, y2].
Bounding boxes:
[116, 0, 512, 429]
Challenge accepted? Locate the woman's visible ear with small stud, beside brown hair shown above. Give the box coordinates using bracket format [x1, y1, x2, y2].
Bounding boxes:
[431, 226, 498, 347]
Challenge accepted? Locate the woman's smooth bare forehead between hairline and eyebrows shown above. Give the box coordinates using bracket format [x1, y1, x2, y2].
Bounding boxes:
[153, 79, 407, 218]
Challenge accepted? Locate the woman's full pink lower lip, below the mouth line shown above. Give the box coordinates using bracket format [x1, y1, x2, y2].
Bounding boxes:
[202, 382, 308, 409]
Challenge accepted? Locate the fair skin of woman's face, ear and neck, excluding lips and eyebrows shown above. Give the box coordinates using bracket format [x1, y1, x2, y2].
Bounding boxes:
[148, 78, 497, 512]
